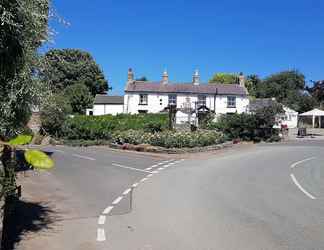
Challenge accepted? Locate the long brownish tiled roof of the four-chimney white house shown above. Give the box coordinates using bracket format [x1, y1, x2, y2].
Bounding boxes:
[125, 81, 247, 96]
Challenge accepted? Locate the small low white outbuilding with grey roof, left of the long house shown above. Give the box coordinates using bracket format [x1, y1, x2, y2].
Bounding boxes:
[86, 95, 124, 116]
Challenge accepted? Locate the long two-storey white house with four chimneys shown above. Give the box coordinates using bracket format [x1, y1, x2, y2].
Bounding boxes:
[124, 69, 249, 123]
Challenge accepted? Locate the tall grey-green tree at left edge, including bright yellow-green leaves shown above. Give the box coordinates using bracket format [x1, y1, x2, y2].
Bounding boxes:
[0, 0, 53, 249]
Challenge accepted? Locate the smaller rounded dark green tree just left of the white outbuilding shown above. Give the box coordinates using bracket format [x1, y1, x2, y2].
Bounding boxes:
[64, 83, 93, 114]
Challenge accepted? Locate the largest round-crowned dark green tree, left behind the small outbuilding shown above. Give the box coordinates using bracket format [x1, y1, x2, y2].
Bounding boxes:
[42, 49, 108, 96]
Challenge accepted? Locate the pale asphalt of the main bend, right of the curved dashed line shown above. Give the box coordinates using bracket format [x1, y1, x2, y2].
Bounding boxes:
[105, 142, 324, 250]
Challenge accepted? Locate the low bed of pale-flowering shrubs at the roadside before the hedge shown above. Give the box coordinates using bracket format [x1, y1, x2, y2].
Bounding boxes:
[113, 130, 223, 148]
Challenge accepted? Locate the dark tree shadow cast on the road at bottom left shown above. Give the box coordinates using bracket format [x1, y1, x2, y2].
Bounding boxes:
[2, 200, 57, 250]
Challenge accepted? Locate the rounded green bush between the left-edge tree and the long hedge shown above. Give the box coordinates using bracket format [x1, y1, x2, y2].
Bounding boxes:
[40, 94, 72, 135]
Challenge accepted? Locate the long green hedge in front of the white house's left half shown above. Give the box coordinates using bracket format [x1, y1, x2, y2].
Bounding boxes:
[60, 114, 168, 140]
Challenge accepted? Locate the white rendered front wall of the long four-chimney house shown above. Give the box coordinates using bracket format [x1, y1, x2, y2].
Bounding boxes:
[124, 93, 249, 114]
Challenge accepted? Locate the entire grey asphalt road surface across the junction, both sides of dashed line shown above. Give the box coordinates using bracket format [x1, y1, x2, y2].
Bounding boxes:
[18, 141, 324, 250]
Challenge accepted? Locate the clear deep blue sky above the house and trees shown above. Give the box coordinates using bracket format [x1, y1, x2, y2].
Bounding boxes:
[50, 0, 324, 94]
